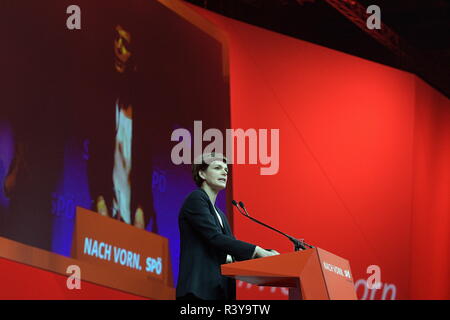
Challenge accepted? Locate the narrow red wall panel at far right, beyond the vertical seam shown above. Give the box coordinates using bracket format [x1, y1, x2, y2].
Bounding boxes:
[410, 79, 450, 299]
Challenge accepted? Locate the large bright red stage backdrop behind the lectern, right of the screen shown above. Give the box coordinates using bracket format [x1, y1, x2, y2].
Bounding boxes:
[193, 7, 450, 299]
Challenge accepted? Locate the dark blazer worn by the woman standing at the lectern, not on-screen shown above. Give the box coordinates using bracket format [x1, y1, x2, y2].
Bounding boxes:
[176, 188, 256, 300]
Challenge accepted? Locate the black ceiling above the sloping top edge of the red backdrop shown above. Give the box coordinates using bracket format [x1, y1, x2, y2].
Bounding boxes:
[186, 0, 450, 97]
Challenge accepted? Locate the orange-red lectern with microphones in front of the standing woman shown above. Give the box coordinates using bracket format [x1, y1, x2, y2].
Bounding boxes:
[221, 248, 357, 300]
